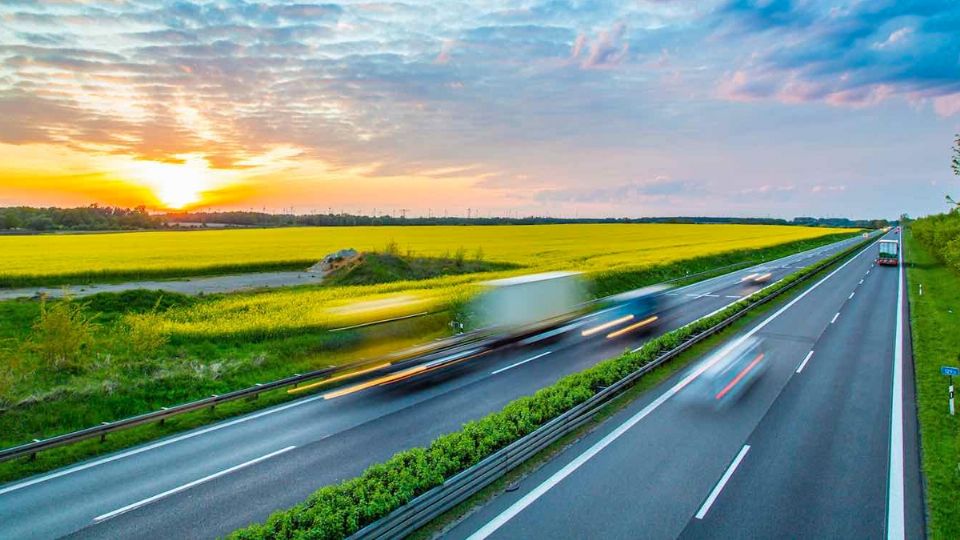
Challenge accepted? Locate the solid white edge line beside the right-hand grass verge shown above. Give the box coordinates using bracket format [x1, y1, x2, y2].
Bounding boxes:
[887, 247, 906, 540]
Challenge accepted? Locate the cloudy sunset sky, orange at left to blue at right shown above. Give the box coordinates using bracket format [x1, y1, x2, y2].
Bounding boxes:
[0, 0, 960, 218]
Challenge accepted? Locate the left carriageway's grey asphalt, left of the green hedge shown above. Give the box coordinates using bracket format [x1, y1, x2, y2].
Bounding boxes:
[0, 234, 872, 539]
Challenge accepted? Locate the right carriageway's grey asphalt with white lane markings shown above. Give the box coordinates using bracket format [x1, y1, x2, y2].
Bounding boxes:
[445, 232, 924, 540]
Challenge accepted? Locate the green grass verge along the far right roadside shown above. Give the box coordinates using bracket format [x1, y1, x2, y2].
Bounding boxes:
[903, 229, 960, 539]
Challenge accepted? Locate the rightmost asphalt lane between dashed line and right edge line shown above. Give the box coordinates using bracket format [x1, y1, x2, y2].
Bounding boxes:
[682, 255, 897, 538]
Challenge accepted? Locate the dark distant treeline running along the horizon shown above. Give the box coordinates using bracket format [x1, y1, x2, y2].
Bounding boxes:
[0, 205, 891, 234]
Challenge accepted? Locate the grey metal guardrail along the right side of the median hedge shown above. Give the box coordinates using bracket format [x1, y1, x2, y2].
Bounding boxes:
[350, 237, 873, 540]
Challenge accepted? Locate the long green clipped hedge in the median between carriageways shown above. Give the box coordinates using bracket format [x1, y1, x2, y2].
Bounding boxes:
[231, 240, 870, 539]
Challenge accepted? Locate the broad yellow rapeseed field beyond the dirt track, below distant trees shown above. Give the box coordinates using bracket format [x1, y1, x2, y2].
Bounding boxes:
[0, 224, 856, 282]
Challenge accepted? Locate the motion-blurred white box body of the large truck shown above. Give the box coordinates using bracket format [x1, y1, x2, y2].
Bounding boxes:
[473, 272, 586, 334]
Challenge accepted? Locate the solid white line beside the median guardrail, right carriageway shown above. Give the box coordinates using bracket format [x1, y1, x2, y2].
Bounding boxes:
[467, 244, 873, 540]
